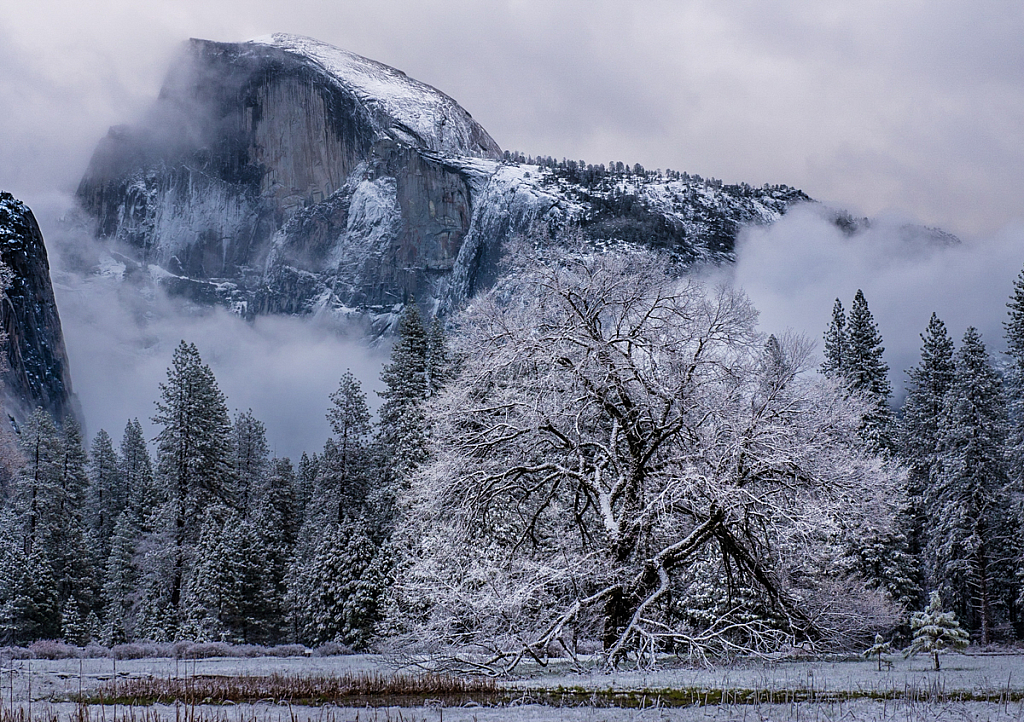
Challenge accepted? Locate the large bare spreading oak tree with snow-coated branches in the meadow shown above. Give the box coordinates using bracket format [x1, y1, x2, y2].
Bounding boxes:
[396, 241, 896, 672]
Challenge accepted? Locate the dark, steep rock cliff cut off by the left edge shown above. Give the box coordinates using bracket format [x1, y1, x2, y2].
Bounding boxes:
[0, 192, 75, 423]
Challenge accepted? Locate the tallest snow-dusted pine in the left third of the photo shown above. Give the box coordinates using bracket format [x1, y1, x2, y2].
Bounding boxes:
[153, 341, 234, 626]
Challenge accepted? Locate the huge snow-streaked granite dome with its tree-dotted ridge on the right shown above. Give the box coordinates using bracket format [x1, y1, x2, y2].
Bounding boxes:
[78, 35, 808, 317]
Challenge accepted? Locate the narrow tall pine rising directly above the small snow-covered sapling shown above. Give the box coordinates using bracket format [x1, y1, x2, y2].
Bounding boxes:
[898, 313, 954, 605]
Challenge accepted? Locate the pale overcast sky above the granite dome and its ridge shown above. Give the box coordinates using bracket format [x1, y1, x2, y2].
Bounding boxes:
[0, 0, 1024, 235]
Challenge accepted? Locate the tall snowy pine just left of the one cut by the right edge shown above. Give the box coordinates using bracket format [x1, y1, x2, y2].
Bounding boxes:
[926, 328, 1008, 644]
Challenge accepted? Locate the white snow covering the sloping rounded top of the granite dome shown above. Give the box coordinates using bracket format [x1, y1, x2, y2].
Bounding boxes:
[249, 33, 501, 157]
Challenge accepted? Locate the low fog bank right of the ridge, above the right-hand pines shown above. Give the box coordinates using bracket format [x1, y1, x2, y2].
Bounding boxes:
[731, 205, 1024, 400]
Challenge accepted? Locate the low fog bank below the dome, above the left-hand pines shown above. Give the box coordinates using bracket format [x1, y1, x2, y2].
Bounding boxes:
[40, 204, 387, 462]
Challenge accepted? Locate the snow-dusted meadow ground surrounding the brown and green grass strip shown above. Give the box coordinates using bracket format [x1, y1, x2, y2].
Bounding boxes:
[0, 655, 1024, 722]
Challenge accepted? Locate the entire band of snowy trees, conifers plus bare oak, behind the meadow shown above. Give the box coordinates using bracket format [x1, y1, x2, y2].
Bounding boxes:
[0, 237, 1024, 674]
